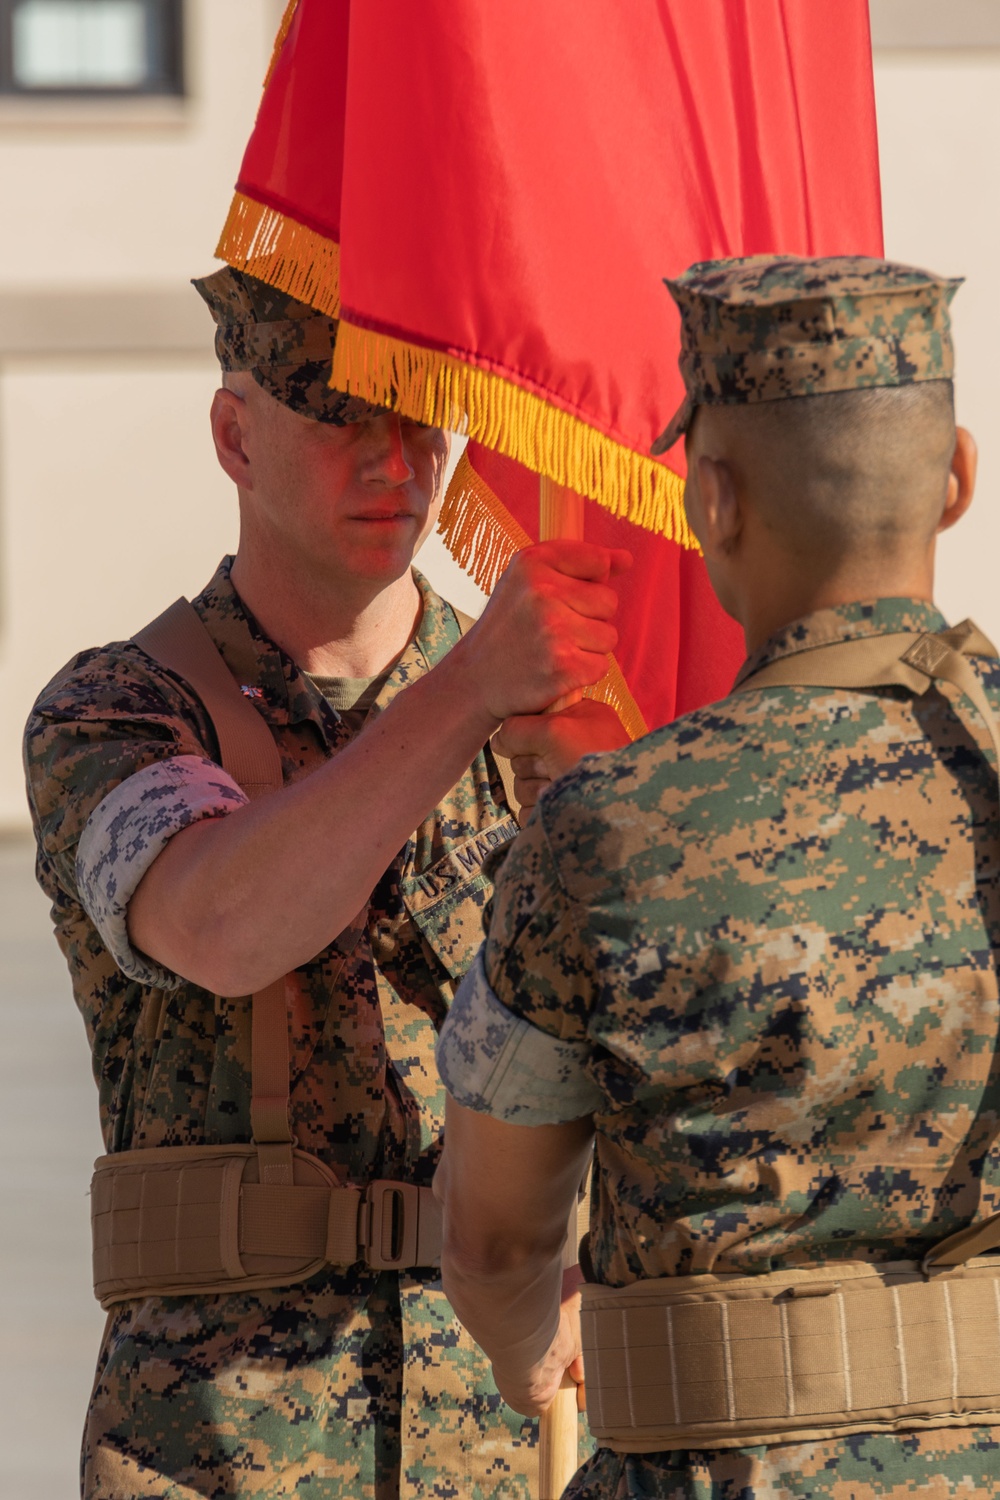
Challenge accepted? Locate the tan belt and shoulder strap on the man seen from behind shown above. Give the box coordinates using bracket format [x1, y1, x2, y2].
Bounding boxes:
[582, 621, 1000, 1454]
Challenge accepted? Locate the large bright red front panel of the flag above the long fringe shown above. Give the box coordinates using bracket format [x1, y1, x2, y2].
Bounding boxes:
[340, 0, 882, 453]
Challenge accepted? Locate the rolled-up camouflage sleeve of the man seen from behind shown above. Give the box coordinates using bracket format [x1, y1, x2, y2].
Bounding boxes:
[438, 815, 603, 1125]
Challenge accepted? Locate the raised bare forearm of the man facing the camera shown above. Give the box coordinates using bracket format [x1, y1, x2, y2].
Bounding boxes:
[129, 647, 496, 995]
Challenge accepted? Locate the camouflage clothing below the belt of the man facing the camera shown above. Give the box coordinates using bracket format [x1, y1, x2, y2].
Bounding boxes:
[82, 1274, 537, 1500]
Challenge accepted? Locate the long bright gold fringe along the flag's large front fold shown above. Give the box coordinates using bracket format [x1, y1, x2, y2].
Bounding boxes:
[330, 321, 697, 548]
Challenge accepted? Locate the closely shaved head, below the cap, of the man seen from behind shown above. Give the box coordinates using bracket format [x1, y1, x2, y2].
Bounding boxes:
[688, 381, 955, 567]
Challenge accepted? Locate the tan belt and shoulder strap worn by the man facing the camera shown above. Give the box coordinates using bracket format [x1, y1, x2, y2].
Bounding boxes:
[90, 599, 441, 1308]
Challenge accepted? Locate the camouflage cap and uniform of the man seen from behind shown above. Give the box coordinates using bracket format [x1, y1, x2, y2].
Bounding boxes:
[438, 258, 1000, 1500]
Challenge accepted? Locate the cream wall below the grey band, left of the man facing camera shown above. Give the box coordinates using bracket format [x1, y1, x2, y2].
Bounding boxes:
[0, 356, 235, 828]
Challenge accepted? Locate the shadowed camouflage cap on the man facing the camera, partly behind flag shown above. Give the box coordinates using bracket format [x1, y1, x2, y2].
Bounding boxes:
[192, 266, 385, 428]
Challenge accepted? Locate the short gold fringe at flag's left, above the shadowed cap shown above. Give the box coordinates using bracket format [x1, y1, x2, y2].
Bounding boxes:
[216, 192, 340, 318]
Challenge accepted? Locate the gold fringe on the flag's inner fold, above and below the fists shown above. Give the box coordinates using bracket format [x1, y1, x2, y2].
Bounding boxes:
[437, 450, 649, 740]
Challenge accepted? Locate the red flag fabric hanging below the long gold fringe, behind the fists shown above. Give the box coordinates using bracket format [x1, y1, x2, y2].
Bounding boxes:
[466, 443, 745, 729]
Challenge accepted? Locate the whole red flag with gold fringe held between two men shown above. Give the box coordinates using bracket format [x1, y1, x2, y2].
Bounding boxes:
[217, 0, 882, 734]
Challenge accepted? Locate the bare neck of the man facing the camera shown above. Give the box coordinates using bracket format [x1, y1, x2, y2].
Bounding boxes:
[232, 534, 421, 678]
